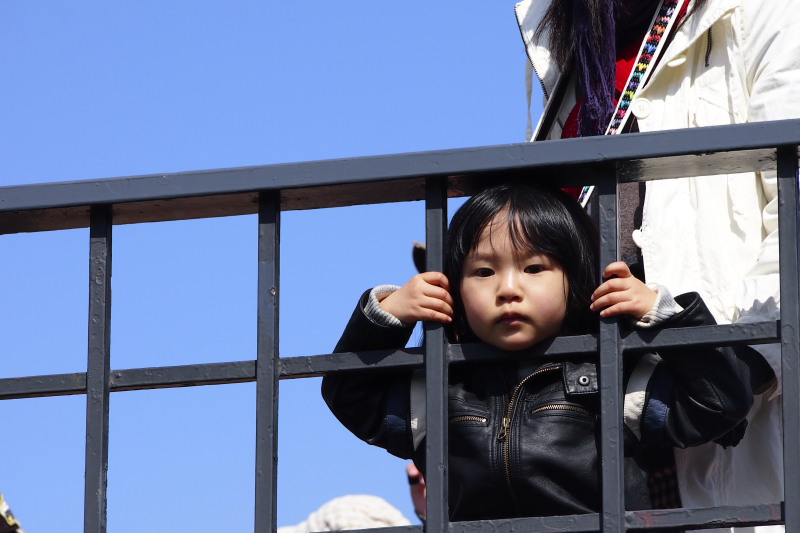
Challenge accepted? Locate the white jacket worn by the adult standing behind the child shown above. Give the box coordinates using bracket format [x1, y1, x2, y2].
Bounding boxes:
[516, 0, 800, 533]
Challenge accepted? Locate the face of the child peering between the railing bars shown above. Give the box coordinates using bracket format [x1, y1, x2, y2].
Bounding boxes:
[461, 212, 569, 350]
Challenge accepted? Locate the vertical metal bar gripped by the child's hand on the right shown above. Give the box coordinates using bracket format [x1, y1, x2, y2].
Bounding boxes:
[597, 172, 625, 533]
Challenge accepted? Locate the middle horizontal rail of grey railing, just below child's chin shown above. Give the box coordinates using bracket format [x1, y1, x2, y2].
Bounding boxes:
[0, 322, 780, 400]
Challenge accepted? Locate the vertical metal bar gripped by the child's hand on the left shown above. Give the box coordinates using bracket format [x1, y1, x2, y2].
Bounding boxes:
[425, 179, 449, 532]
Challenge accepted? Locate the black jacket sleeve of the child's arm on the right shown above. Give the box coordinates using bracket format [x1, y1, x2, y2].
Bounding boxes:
[641, 293, 775, 448]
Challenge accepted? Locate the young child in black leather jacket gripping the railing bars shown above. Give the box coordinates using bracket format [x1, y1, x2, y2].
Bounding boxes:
[322, 183, 773, 521]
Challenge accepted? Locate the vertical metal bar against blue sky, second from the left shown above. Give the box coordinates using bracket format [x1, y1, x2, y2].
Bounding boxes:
[255, 192, 280, 533]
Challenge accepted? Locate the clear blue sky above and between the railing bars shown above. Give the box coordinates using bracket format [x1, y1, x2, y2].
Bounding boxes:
[0, 0, 544, 533]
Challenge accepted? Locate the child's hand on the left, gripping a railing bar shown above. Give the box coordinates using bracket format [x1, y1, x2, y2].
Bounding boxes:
[380, 272, 453, 324]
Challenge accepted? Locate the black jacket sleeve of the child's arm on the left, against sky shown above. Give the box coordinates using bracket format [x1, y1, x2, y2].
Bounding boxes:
[322, 291, 414, 459]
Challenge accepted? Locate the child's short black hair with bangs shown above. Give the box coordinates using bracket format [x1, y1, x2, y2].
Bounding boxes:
[444, 181, 599, 342]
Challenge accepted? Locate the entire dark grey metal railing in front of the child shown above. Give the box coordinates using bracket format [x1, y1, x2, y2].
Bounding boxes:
[0, 120, 800, 533]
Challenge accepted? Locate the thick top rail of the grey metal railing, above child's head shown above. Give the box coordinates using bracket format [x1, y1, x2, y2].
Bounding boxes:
[0, 120, 800, 234]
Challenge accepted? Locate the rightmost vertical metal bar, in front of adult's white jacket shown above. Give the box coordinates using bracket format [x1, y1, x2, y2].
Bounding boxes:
[778, 146, 800, 531]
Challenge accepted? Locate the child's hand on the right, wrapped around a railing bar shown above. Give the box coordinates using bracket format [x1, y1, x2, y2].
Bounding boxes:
[589, 261, 658, 320]
